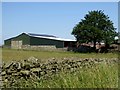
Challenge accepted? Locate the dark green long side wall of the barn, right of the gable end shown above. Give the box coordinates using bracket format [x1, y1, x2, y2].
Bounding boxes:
[30, 37, 64, 48]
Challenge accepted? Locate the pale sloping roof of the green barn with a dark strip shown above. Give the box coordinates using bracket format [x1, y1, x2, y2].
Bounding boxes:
[27, 33, 76, 41]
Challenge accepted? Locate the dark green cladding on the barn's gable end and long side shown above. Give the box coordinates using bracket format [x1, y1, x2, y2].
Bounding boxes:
[4, 33, 64, 48]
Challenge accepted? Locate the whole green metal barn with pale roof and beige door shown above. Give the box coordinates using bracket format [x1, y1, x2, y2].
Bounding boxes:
[4, 33, 76, 48]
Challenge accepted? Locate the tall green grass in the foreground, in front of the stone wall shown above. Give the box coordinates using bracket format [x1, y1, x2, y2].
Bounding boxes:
[8, 63, 118, 88]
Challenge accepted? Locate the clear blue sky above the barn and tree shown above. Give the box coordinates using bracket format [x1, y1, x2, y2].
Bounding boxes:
[0, 2, 118, 44]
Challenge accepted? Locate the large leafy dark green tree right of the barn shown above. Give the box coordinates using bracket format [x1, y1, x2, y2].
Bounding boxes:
[72, 10, 117, 49]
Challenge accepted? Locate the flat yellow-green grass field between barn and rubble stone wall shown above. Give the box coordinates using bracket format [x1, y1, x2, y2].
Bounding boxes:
[2, 49, 118, 62]
